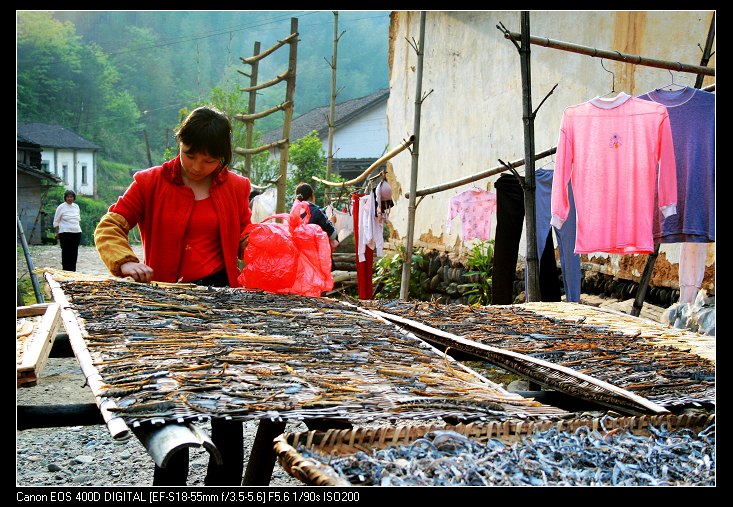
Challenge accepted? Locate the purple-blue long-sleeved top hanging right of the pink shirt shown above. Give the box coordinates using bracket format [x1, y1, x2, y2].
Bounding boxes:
[639, 86, 715, 245]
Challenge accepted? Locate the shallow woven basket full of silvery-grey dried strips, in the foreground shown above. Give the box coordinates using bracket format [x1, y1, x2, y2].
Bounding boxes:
[275, 416, 716, 486]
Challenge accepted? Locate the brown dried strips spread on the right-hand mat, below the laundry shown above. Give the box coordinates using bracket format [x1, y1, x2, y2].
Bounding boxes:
[362, 300, 715, 412]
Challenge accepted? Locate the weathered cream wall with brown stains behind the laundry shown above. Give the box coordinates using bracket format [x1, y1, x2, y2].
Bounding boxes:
[387, 11, 715, 289]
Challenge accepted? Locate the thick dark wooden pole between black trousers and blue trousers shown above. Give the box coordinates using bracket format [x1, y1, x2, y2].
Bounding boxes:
[519, 11, 540, 302]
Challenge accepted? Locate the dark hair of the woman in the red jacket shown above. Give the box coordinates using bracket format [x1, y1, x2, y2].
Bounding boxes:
[176, 106, 232, 171]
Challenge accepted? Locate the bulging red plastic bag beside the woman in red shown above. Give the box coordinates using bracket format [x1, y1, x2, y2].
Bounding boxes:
[238, 213, 300, 294]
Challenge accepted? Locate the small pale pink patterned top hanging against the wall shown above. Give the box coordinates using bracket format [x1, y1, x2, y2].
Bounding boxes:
[446, 187, 496, 241]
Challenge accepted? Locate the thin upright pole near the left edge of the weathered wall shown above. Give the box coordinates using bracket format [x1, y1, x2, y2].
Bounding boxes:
[400, 11, 426, 300]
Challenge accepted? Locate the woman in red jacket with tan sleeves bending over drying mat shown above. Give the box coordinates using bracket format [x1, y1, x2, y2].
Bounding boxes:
[94, 107, 252, 486]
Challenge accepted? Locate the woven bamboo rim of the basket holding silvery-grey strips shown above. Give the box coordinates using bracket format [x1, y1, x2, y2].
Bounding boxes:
[273, 414, 715, 487]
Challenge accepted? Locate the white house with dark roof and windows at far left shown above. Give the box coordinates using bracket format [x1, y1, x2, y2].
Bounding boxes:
[17, 123, 101, 197]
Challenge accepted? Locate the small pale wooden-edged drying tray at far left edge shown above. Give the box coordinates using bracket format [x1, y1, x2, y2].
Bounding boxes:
[15, 303, 61, 388]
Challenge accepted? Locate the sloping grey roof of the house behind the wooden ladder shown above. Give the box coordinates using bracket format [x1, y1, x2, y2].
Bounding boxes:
[262, 88, 389, 144]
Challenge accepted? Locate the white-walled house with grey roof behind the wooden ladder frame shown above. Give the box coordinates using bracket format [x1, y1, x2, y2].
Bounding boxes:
[262, 89, 389, 179]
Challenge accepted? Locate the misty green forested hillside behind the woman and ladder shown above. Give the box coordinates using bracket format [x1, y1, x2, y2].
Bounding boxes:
[16, 11, 389, 188]
